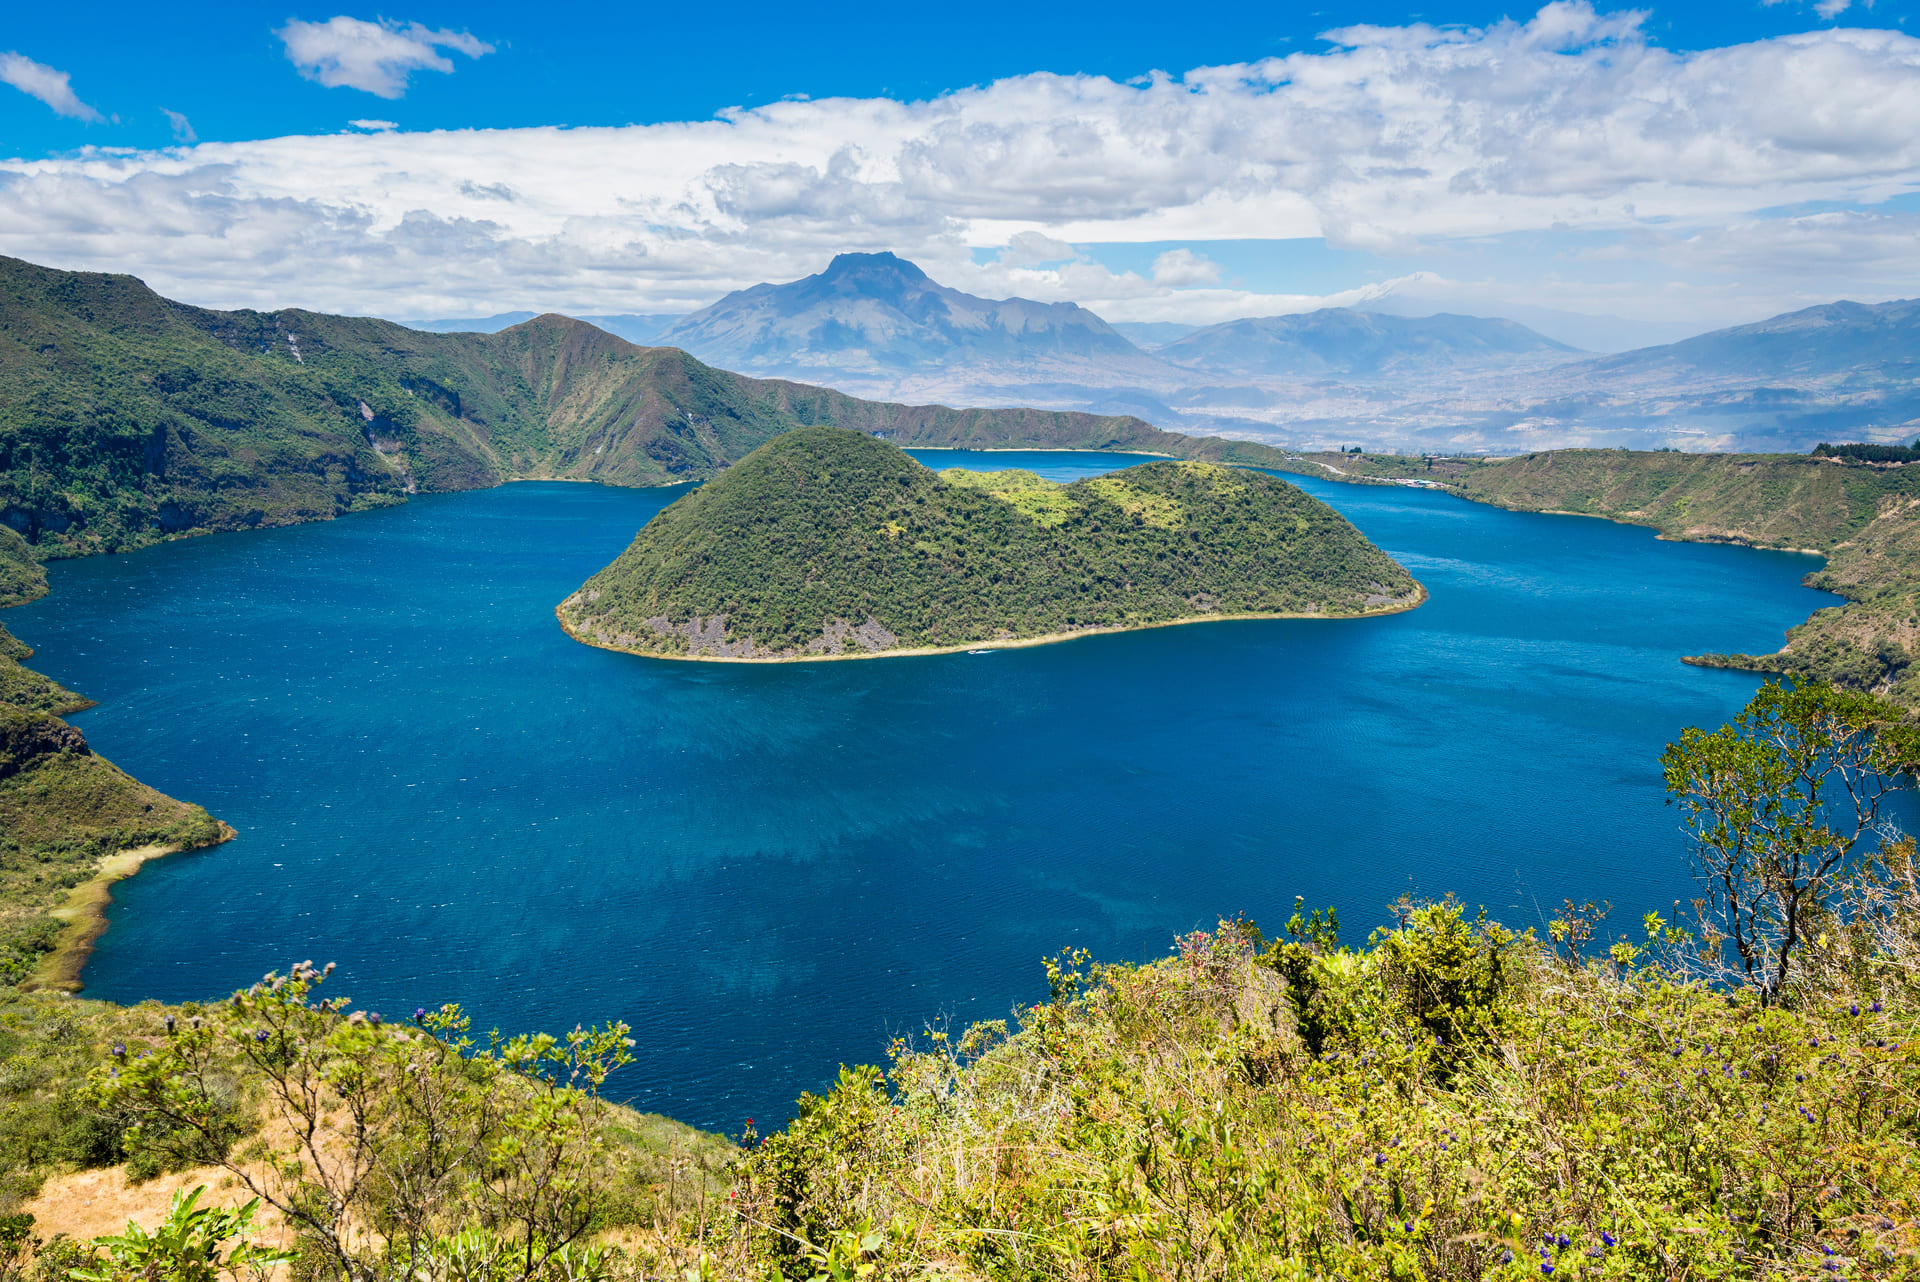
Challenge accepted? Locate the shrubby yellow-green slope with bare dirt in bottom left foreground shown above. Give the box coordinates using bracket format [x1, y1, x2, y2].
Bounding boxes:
[0, 967, 735, 1282]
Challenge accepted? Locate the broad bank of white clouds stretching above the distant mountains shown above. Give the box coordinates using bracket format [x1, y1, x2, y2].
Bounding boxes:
[0, 0, 1920, 319]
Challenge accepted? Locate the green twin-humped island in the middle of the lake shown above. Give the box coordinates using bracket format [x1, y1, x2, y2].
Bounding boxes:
[559, 428, 1423, 658]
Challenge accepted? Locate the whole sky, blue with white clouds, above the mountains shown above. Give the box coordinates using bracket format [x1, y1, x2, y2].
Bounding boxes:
[0, 0, 1920, 340]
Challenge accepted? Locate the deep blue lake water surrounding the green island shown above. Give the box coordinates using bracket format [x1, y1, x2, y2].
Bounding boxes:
[6, 451, 1834, 1130]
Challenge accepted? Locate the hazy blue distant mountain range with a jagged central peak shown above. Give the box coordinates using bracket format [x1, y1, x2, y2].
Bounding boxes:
[393, 253, 1920, 453]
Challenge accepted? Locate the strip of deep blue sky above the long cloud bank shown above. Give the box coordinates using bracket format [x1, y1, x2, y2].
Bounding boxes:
[0, 0, 1912, 157]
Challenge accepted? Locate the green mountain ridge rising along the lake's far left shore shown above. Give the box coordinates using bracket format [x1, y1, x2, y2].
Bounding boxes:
[0, 257, 1275, 556]
